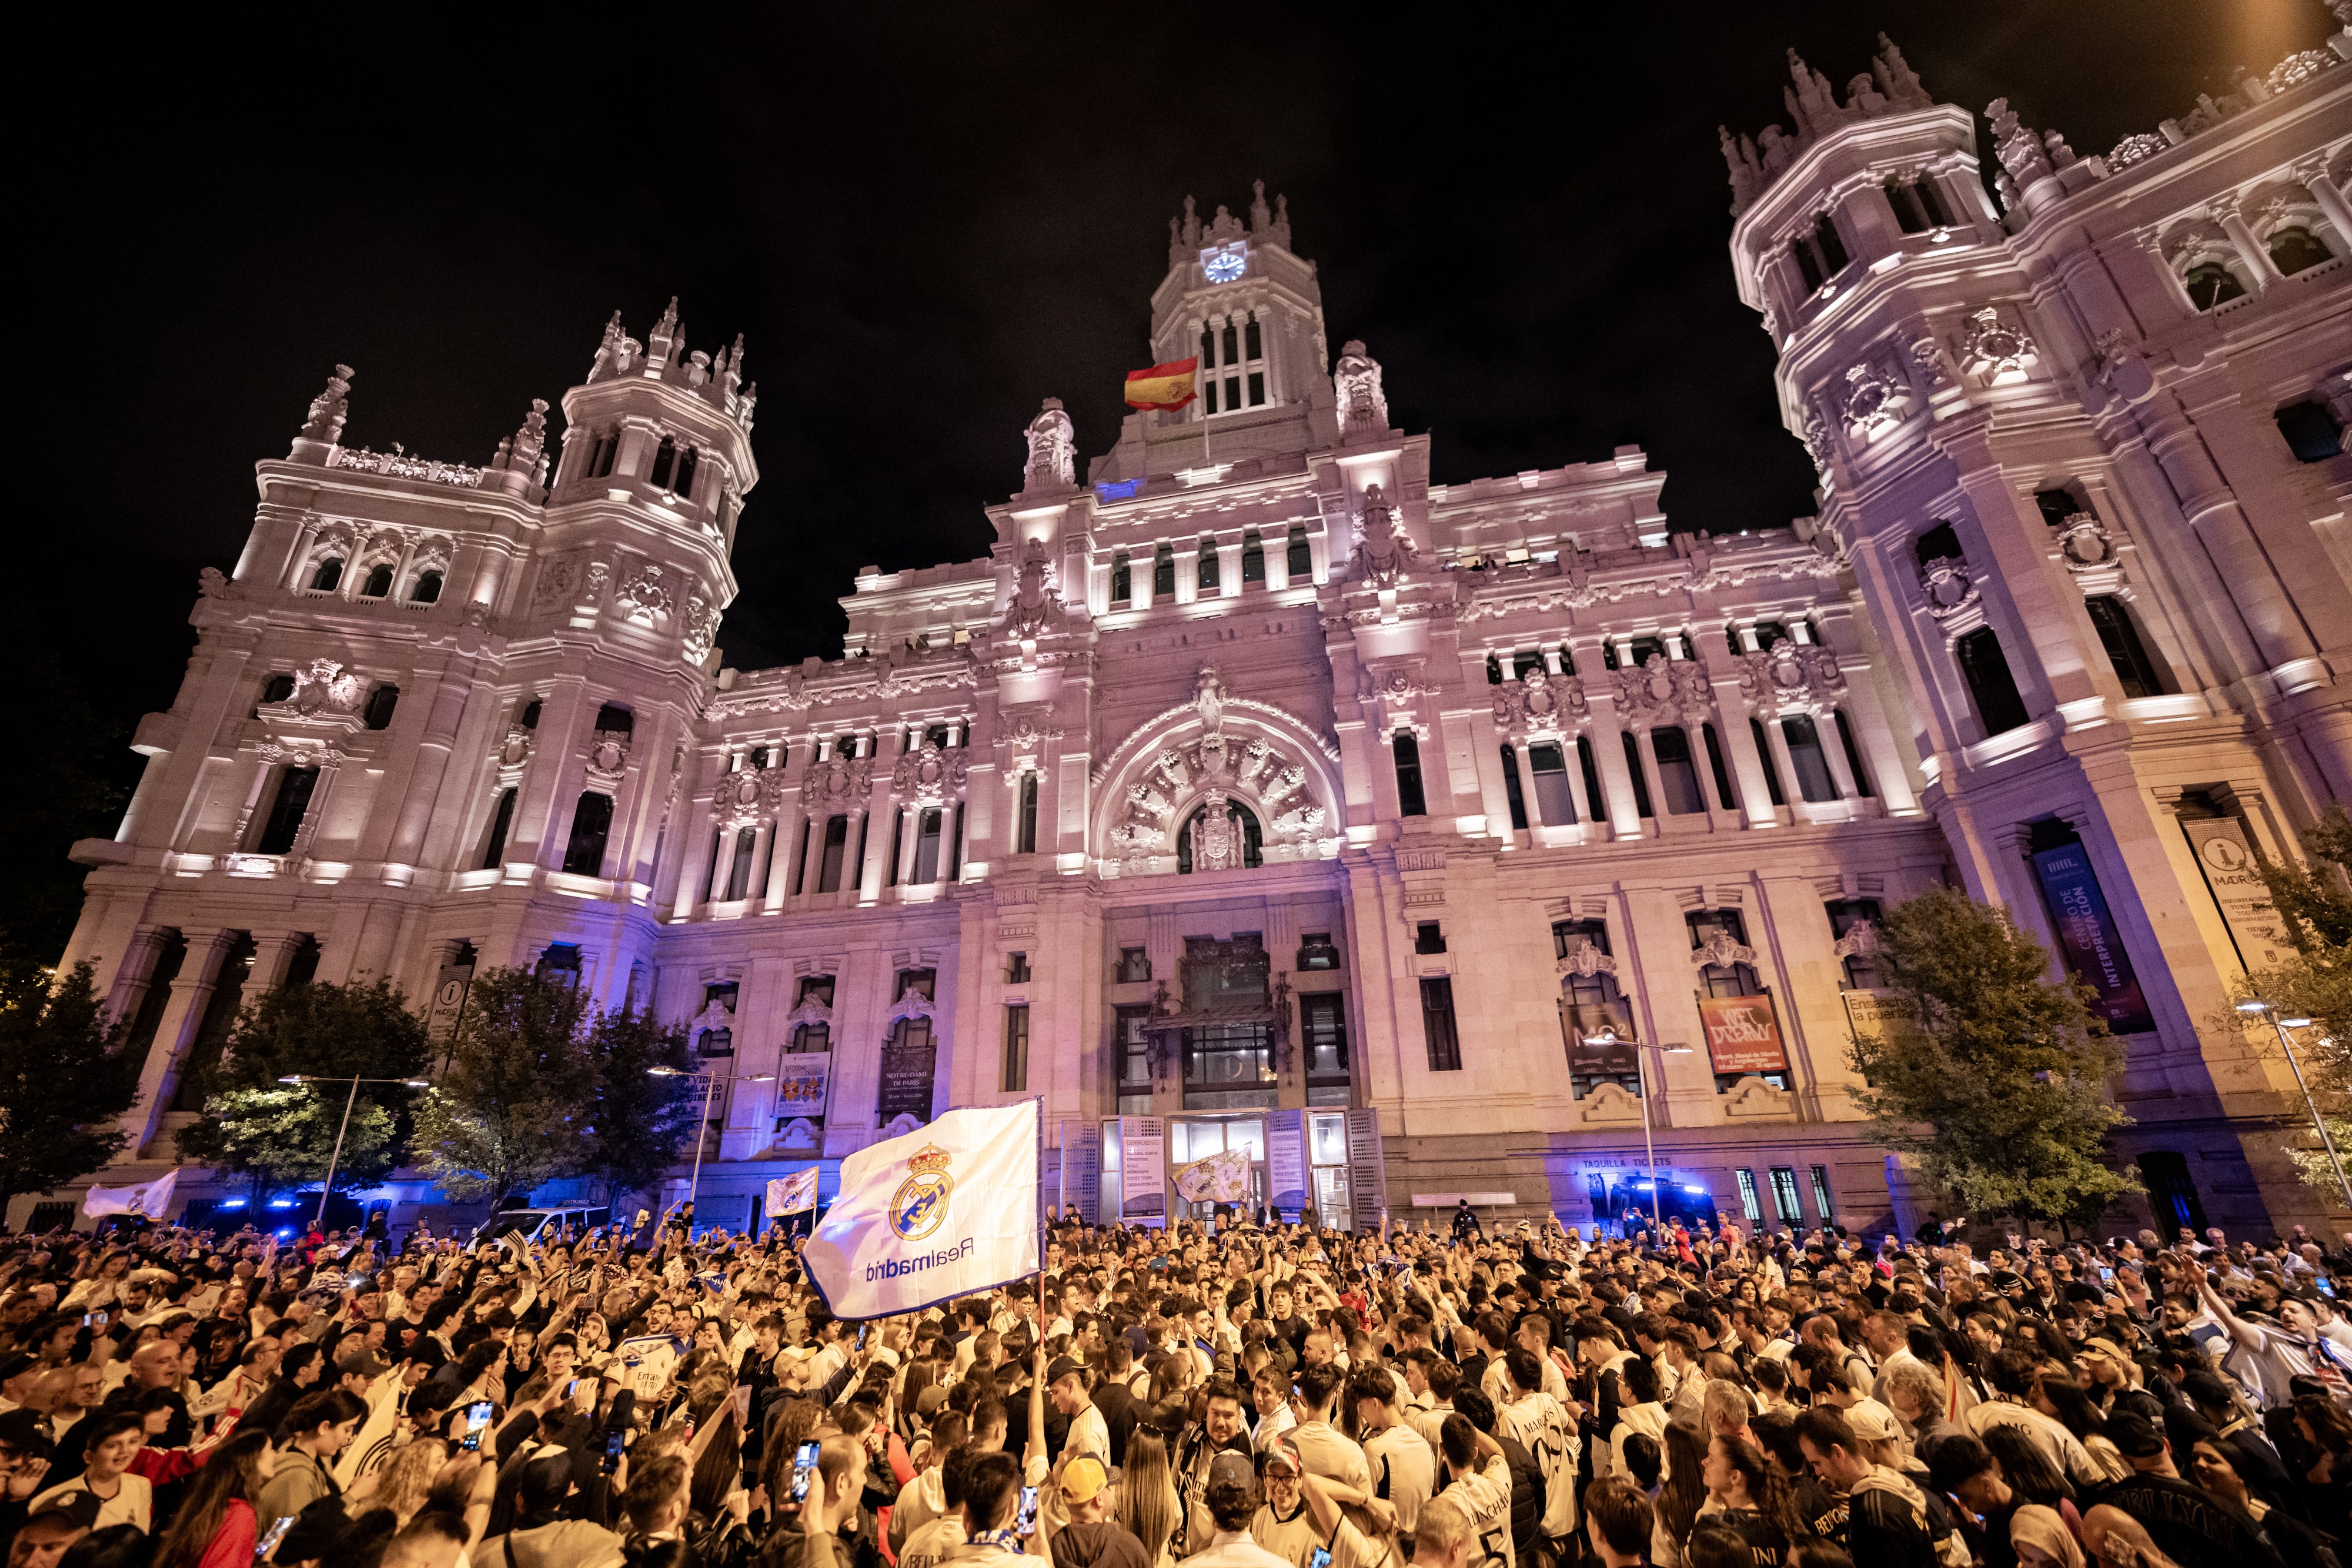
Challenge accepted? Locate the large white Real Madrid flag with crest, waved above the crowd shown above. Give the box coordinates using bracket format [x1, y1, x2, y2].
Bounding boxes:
[802, 1100, 1040, 1319]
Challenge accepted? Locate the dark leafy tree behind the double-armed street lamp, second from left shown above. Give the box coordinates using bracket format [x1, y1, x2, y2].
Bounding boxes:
[179, 980, 426, 1196]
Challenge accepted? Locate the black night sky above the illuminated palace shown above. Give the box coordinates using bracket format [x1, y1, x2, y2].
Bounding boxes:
[12, 0, 2331, 766]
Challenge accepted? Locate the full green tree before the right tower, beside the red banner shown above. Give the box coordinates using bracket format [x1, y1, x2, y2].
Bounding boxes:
[1846, 888, 2140, 1227]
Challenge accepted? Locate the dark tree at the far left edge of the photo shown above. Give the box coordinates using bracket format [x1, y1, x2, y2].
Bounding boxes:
[0, 964, 143, 1213]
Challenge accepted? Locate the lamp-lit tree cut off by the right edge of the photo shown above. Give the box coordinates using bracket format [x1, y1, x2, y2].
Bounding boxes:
[2218, 806, 2352, 1192]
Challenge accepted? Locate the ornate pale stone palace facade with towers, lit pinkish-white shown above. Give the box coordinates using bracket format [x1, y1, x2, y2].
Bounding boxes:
[32, 9, 2352, 1232]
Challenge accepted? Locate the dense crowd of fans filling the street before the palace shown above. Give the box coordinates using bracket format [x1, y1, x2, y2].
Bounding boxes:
[0, 1208, 2352, 1568]
